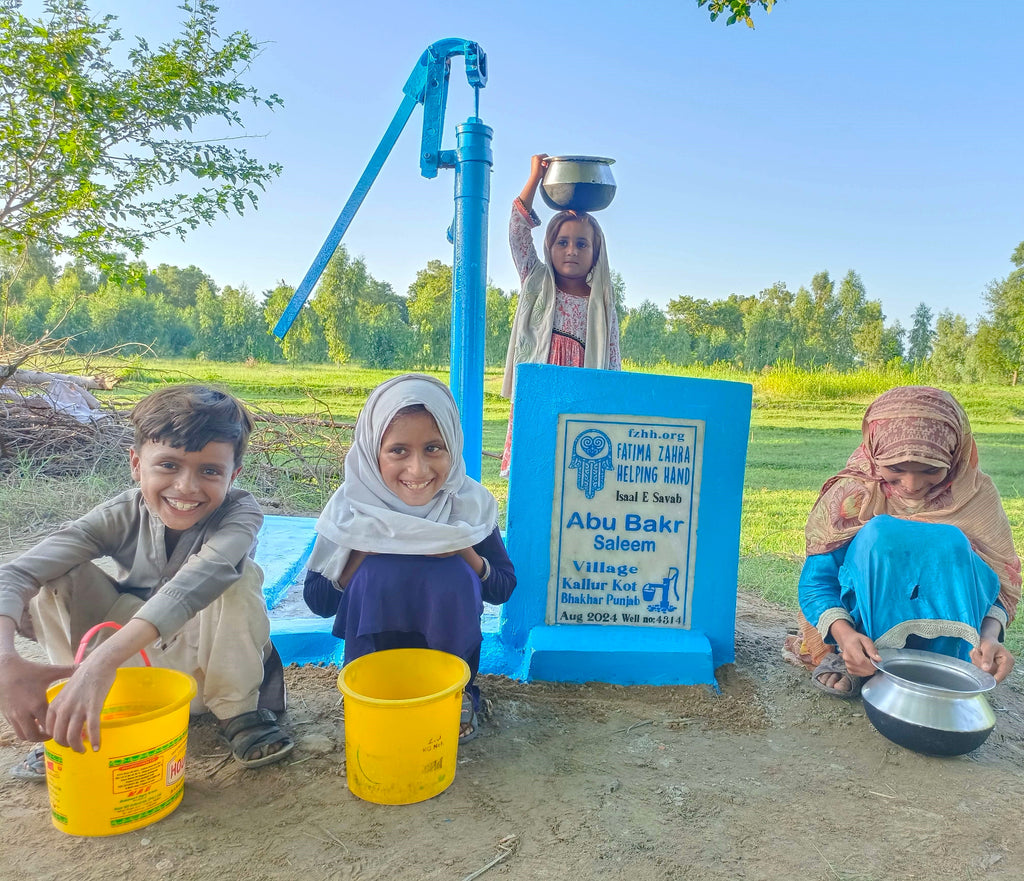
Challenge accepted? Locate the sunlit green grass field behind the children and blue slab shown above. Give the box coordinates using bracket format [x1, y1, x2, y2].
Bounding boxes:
[16, 361, 1024, 651]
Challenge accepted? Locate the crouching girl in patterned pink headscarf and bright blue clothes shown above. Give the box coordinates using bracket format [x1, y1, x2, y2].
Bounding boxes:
[799, 386, 1021, 698]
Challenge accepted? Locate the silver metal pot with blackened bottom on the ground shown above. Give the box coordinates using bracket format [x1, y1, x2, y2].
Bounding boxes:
[861, 648, 995, 756]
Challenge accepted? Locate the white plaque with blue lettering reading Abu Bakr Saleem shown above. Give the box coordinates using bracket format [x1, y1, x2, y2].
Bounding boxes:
[547, 413, 705, 629]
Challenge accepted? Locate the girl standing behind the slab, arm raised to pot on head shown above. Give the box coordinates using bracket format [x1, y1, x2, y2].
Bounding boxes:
[502, 153, 622, 477]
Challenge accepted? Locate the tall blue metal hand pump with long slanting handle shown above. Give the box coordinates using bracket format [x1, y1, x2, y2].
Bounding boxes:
[273, 38, 493, 479]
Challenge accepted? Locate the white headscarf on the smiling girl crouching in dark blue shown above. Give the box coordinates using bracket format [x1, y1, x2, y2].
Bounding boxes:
[308, 373, 498, 584]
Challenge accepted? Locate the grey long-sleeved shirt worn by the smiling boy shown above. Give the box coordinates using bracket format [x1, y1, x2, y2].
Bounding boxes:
[0, 488, 263, 640]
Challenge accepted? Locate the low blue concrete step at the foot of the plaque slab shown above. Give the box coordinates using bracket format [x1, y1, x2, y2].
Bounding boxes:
[516, 625, 717, 688]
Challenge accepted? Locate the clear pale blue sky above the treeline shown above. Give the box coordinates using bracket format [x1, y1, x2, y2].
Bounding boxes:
[46, 0, 1024, 327]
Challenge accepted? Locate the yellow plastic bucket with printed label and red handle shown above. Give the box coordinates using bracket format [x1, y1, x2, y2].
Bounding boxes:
[44, 667, 196, 835]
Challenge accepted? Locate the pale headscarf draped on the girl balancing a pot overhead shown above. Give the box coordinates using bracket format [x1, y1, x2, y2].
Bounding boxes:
[502, 211, 615, 397]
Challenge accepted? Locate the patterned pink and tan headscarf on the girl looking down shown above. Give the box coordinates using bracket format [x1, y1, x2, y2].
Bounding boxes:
[806, 385, 1021, 621]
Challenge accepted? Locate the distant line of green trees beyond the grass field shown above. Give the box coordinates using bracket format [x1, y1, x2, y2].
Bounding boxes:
[3, 243, 1024, 383]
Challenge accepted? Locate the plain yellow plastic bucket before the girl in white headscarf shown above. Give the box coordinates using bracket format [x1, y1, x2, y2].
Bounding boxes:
[338, 648, 469, 804]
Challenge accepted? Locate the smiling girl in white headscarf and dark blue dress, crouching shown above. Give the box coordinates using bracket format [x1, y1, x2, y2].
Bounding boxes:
[303, 374, 516, 742]
